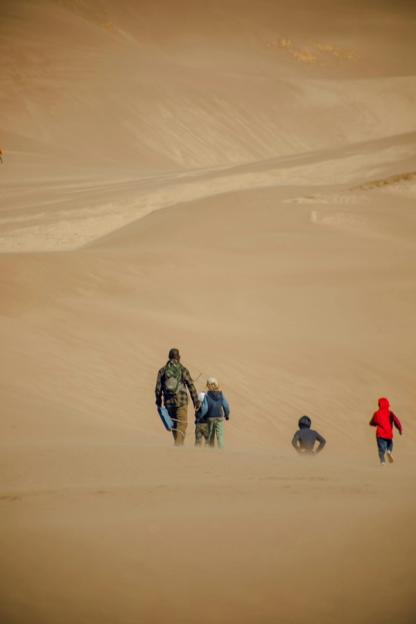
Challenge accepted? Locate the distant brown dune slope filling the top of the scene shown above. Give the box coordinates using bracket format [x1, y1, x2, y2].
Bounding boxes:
[0, 0, 416, 169]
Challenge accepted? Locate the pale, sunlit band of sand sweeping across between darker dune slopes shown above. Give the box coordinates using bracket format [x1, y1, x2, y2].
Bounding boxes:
[0, 133, 416, 252]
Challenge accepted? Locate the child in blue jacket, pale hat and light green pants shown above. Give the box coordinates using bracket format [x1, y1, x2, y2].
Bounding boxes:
[197, 377, 230, 449]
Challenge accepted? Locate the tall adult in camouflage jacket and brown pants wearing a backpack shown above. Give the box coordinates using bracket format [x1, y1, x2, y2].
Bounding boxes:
[155, 349, 199, 446]
